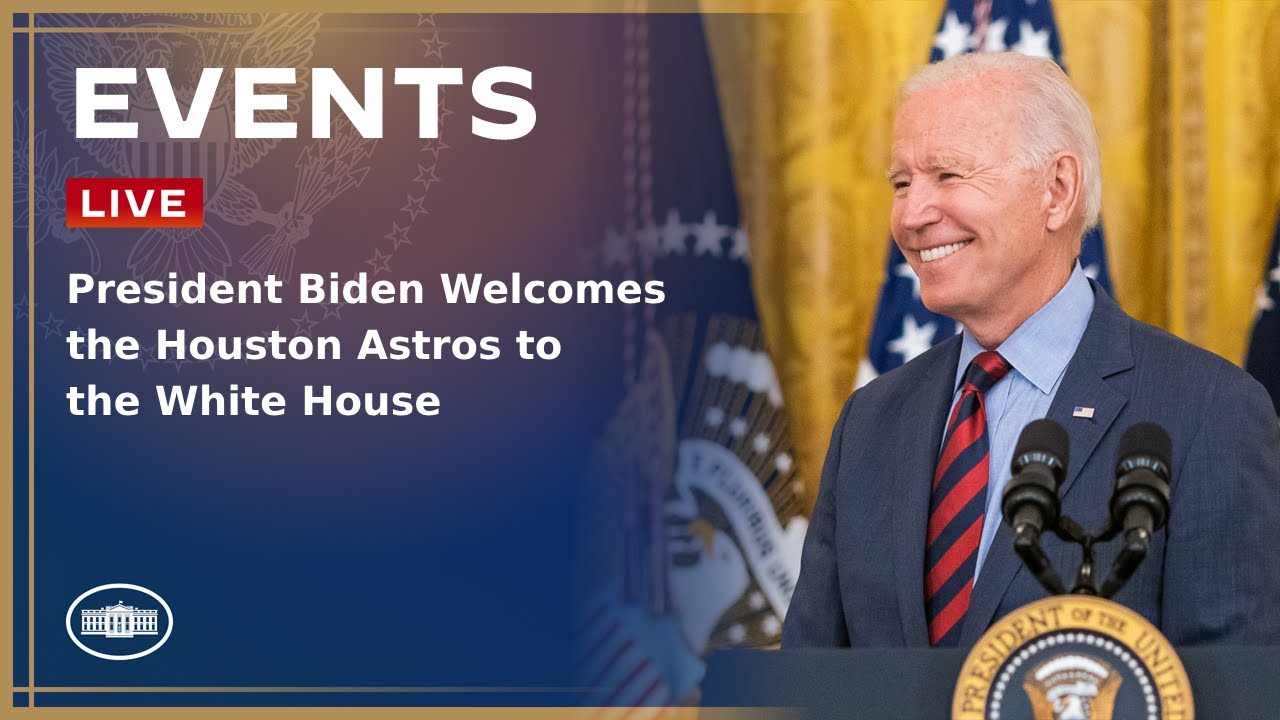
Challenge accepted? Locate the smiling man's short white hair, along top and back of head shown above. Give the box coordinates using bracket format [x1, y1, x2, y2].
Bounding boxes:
[901, 53, 1102, 229]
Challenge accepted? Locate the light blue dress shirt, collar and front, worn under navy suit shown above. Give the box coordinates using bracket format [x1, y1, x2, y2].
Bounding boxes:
[947, 263, 1093, 579]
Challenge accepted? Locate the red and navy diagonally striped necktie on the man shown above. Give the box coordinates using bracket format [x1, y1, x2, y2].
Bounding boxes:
[924, 351, 1010, 646]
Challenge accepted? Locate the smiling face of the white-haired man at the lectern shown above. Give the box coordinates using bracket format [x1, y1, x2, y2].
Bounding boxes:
[890, 77, 1074, 325]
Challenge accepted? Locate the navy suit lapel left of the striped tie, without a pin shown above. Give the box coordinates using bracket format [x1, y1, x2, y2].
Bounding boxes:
[884, 336, 960, 647]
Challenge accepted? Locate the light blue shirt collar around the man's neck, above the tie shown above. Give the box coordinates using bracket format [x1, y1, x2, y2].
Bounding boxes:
[955, 261, 1093, 395]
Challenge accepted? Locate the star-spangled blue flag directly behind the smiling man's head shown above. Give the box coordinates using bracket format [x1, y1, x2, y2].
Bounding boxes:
[858, 0, 1116, 387]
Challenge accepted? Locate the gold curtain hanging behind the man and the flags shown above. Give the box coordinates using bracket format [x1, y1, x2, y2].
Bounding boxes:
[707, 0, 1280, 507]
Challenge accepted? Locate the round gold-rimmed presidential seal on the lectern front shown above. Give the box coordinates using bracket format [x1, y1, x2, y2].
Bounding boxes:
[951, 594, 1196, 720]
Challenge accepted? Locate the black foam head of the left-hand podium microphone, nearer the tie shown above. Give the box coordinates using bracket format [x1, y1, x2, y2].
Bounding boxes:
[1001, 419, 1069, 536]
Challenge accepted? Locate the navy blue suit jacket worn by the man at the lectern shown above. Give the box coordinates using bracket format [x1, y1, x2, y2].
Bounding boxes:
[782, 286, 1280, 647]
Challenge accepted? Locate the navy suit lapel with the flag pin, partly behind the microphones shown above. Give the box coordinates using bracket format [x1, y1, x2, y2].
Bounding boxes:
[960, 281, 1133, 646]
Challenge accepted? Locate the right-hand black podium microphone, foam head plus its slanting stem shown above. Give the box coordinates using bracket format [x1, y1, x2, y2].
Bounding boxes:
[1101, 423, 1174, 597]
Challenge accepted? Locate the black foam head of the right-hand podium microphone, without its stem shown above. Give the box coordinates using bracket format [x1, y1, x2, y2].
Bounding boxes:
[1111, 423, 1174, 538]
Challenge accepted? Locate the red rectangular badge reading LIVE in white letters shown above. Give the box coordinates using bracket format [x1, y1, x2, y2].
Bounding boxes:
[67, 178, 205, 228]
